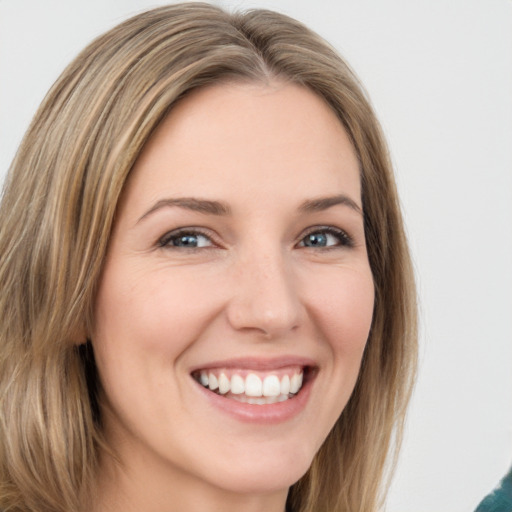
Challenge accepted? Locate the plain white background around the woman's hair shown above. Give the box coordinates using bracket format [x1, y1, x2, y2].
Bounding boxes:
[0, 0, 512, 512]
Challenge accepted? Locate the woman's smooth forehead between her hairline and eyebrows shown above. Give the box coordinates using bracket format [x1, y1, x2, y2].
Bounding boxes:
[121, 82, 360, 212]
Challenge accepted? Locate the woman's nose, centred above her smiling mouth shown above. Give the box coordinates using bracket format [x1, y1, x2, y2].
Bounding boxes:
[227, 251, 304, 339]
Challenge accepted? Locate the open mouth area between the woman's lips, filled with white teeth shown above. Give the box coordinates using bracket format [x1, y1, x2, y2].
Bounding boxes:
[192, 366, 310, 405]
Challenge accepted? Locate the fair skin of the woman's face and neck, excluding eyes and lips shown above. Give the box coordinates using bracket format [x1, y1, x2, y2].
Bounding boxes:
[91, 82, 374, 512]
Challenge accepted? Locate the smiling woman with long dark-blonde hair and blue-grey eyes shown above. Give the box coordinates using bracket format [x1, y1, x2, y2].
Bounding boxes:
[0, 3, 416, 512]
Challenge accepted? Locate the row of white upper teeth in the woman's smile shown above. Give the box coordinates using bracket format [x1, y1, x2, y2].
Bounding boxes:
[199, 371, 304, 397]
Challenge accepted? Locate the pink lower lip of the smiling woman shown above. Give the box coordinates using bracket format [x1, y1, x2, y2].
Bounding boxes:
[193, 377, 314, 425]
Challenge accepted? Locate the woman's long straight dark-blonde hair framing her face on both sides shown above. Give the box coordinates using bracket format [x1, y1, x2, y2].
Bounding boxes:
[0, 3, 416, 512]
